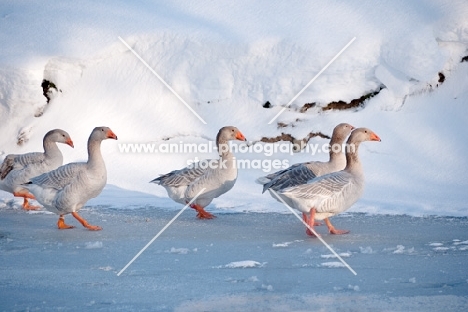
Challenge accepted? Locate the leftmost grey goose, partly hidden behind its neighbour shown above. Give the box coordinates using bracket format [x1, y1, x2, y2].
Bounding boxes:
[0, 129, 73, 210]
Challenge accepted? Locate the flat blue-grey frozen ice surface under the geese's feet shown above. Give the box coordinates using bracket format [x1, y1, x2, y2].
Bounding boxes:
[0, 207, 468, 311]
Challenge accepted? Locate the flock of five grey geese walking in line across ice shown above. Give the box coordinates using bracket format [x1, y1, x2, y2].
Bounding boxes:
[0, 123, 380, 236]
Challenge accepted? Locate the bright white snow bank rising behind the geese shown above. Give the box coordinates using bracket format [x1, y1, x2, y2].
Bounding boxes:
[0, 1, 468, 216]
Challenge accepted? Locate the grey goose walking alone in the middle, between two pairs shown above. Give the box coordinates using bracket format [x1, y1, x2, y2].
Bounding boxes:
[150, 126, 246, 219]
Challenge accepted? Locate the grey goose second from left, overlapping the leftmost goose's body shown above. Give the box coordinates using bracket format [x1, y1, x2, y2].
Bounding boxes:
[24, 127, 117, 231]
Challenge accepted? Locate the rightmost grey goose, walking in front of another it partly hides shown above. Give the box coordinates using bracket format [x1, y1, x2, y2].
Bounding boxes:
[278, 128, 381, 236]
